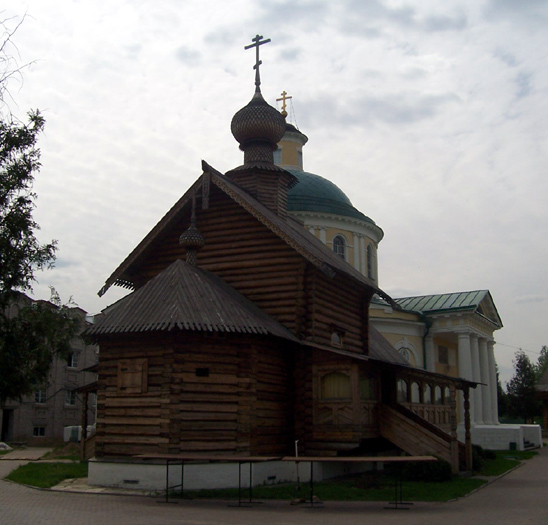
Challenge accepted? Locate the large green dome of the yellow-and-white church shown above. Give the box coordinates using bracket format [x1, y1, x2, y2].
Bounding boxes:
[286, 168, 375, 224]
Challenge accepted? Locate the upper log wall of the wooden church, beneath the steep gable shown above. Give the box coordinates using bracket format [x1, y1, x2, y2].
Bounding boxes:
[127, 187, 370, 353]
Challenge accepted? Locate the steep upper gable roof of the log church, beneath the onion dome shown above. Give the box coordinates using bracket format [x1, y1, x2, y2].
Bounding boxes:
[99, 161, 394, 305]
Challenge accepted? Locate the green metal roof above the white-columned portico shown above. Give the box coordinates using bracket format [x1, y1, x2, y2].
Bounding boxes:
[395, 290, 502, 328]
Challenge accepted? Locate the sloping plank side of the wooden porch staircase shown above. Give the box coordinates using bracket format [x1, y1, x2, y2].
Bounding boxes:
[379, 405, 464, 473]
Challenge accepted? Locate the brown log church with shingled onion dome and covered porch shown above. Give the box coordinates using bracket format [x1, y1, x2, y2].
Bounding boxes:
[89, 37, 475, 471]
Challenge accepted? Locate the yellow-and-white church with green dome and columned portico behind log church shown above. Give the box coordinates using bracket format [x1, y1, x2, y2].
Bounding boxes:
[274, 99, 542, 450]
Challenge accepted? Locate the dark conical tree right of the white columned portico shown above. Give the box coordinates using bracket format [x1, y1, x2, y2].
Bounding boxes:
[506, 350, 542, 423]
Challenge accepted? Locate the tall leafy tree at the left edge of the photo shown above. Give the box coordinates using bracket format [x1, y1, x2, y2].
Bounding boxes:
[0, 15, 78, 405]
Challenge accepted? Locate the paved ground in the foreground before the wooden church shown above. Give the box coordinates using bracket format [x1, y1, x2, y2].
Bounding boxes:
[0, 450, 548, 525]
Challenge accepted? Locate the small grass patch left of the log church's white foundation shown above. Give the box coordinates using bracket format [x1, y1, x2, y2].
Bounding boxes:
[6, 462, 88, 489]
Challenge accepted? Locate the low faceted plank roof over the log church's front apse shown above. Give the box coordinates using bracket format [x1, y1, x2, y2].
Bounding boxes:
[87, 259, 298, 342]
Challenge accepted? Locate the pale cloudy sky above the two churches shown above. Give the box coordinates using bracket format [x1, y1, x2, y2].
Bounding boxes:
[0, 0, 548, 382]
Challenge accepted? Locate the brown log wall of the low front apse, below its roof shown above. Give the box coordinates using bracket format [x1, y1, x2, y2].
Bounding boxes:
[96, 332, 293, 457]
